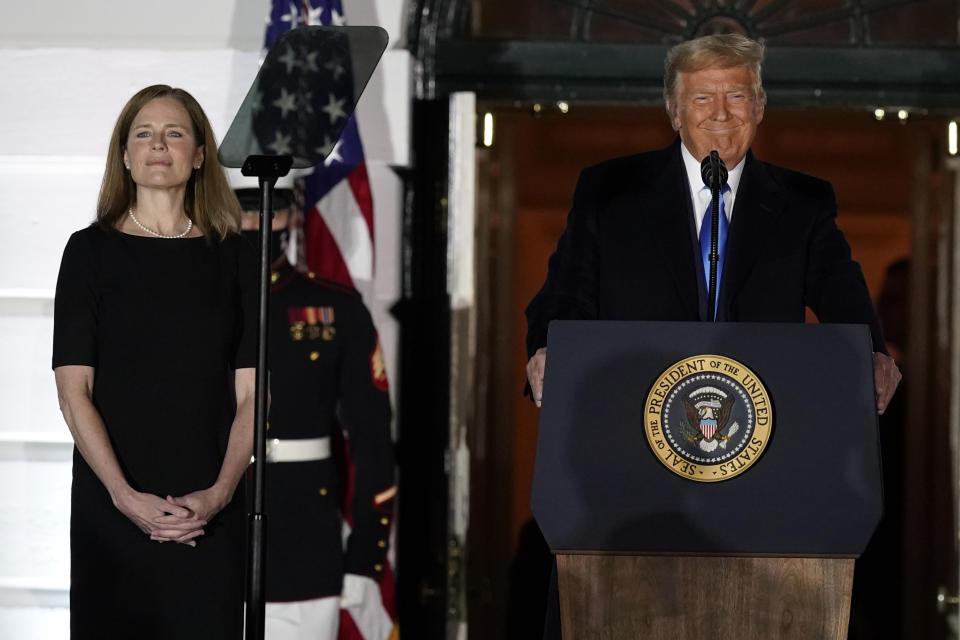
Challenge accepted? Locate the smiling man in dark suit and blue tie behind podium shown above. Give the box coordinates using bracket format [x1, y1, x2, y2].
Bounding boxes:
[526, 35, 900, 413]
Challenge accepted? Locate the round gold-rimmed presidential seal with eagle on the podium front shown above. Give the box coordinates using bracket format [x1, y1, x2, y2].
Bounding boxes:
[644, 355, 773, 482]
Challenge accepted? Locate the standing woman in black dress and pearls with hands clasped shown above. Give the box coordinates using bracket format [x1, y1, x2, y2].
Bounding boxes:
[53, 85, 256, 640]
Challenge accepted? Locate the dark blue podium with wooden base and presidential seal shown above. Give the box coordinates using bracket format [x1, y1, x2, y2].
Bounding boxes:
[532, 321, 883, 640]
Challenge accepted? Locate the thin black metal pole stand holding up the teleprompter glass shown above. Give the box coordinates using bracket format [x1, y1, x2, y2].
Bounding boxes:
[240, 156, 293, 640]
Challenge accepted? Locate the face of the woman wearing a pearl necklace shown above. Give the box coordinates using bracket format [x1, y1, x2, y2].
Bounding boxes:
[123, 98, 203, 189]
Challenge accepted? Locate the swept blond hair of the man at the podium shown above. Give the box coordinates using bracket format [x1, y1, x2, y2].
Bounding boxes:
[663, 33, 767, 104]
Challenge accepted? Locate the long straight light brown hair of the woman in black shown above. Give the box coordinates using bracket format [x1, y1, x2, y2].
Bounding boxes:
[97, 84, 240, 239]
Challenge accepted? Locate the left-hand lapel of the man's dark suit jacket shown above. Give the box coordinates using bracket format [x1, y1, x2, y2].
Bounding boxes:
[639, 138, 701, 318]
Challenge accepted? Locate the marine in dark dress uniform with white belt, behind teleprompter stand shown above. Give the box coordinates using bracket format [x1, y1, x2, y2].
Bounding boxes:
[237, 189, 396, 640]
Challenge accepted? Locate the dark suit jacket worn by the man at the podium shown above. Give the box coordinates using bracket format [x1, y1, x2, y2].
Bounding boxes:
[526, 138, 886, 357]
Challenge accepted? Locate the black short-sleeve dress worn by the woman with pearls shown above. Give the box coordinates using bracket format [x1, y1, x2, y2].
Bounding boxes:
[53, 225, 256, 640]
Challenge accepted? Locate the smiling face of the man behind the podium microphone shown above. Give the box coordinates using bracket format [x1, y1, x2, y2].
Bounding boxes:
[667, 67, 763, 169]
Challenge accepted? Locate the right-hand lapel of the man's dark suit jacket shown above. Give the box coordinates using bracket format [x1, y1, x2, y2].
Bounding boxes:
[718, 152, 784, 320]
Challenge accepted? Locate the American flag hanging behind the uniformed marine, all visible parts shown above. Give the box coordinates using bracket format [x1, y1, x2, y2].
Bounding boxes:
[264, 0, 399, 640]
